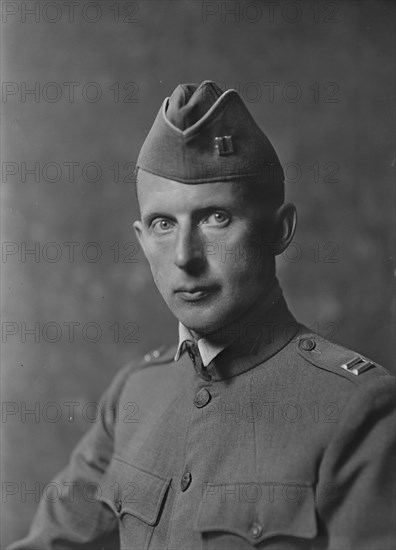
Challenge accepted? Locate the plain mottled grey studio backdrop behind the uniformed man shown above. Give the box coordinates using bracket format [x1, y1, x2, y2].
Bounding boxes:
[1, 0, 395, 548]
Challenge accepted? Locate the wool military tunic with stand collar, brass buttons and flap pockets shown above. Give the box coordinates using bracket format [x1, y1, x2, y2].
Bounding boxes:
[11, 297, 394, 550]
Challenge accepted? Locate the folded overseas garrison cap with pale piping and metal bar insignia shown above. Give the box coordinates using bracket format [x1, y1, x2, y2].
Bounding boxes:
[137, 80, 284, 203]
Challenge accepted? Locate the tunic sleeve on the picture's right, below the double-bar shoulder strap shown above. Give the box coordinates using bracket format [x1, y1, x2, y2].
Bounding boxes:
[317, 375, 396, 550]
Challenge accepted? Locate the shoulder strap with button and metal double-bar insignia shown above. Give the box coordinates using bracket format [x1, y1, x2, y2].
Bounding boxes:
[297, 333, 385, 380]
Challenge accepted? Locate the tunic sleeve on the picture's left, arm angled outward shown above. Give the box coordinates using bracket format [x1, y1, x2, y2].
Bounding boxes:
[9, 367, 135, 550]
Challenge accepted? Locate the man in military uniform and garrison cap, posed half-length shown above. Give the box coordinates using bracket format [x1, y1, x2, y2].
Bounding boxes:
[11, 81, 394, 550]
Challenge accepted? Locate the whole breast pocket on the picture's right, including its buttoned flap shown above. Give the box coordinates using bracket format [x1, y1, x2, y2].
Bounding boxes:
[195, 484, 317, 550]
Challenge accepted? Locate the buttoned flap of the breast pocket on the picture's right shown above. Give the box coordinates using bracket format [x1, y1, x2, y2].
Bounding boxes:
[195, 483, 317, 545]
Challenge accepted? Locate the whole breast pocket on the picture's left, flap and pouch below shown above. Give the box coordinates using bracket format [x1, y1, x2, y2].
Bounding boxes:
[100, 457, 171, 550]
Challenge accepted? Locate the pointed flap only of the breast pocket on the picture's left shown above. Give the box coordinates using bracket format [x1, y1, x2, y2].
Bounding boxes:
[100, 457, 171, 525]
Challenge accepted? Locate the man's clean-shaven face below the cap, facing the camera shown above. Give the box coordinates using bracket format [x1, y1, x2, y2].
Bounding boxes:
[134, 171, 274, 335]
